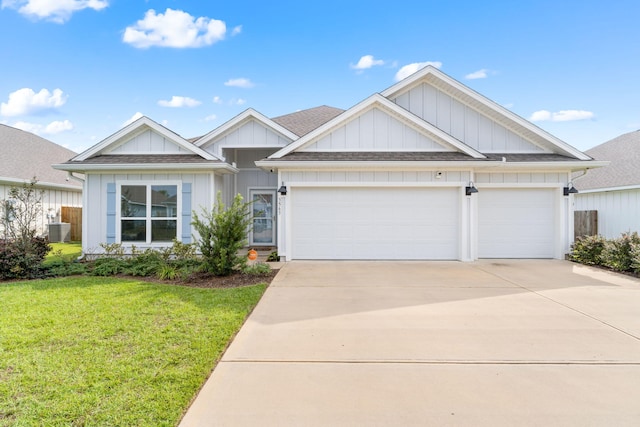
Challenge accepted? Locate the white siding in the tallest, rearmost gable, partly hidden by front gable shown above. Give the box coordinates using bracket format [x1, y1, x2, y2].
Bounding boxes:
[391, 83, 544, 153]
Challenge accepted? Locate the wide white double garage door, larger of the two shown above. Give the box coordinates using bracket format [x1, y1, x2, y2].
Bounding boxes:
[287, 187, 460, 259]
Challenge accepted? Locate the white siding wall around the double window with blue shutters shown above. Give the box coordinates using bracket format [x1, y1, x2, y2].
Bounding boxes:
[82, 173, 216, 254]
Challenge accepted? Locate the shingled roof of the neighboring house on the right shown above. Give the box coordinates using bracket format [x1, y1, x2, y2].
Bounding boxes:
[574, 130, 640, 190]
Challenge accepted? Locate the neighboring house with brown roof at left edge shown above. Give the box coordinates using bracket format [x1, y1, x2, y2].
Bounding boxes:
[0, 124, 82, 235]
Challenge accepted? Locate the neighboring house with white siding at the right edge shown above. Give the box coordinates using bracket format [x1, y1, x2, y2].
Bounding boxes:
[574, 130, 640, 239]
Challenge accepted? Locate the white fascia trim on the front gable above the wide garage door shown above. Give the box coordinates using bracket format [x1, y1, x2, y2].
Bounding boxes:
[269, 93, 486, 159]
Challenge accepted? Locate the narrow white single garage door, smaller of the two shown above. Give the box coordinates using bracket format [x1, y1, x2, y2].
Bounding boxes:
[476, 188, 557, 258]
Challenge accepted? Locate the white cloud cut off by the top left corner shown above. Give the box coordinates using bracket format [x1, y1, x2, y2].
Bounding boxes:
[2, 0, 109, 24]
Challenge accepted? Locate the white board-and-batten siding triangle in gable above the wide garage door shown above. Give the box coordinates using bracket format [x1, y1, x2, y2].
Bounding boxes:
[300, 108, 452, 152]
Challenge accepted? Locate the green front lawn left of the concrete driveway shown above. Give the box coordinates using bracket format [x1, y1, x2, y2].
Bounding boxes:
[0, 277, 266, 426]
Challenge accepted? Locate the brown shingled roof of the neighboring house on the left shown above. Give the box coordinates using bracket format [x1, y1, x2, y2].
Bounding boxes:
[0, 124, 82, 189]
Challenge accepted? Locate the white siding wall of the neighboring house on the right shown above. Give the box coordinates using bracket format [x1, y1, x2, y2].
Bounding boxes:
[573, 188, 640, 239]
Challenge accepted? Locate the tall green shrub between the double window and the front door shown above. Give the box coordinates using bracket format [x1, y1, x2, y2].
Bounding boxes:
[191, 192, 252, 276]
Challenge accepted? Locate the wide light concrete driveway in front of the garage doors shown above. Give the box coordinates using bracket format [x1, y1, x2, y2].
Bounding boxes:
[181, 260, 640, 427]
